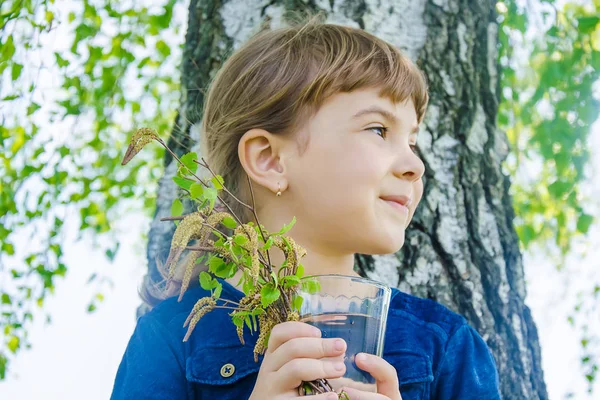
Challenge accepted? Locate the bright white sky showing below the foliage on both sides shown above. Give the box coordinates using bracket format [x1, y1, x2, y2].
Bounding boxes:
[0, 0, 600, 400]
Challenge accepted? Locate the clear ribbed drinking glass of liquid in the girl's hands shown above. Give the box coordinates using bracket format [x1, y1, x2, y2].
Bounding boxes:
[298, 274, 392, 388]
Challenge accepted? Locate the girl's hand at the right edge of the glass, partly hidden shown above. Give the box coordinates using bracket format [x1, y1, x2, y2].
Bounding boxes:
[342, 353, 402, 400]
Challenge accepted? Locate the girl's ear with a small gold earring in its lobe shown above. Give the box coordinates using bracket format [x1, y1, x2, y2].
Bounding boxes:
[238, 129, 287, 193]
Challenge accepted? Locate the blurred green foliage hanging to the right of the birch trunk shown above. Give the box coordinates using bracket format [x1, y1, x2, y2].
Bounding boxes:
[496, 0, 600, 392]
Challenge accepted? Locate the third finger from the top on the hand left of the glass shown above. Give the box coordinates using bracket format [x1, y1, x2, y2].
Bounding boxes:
[274, 358, 346, 390]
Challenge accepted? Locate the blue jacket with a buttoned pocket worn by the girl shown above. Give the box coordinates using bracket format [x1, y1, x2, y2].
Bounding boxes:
[111, 279, 501, 400]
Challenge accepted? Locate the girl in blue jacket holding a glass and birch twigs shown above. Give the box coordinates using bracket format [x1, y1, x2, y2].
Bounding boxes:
[112, 14, 500, 400]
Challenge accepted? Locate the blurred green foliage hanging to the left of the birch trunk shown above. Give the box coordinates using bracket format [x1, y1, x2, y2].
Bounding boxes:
[0, 0, 185, 380]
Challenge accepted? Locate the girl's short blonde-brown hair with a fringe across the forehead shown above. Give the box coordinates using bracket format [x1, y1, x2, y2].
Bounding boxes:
[142, 11, 428, 310]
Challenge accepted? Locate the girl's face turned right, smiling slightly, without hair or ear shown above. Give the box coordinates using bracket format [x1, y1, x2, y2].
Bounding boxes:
[282, 88, 424, 255]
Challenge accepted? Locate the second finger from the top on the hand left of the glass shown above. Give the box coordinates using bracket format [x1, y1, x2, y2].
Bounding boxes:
[269, 337, 346, 371]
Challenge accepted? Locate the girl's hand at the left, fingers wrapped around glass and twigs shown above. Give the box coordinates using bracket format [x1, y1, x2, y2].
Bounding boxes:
[249, 321, 346, 400]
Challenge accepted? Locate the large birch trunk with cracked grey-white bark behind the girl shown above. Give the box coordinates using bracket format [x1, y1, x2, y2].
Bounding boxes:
[138, 0, 548, 399]
